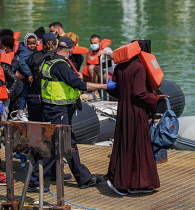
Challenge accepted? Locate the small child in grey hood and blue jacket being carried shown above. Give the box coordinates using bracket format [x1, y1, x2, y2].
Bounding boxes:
[16, 33, 37, 122]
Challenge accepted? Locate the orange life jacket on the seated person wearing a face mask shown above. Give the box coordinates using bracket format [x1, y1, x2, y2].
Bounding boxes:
[82, 39, 112, 77]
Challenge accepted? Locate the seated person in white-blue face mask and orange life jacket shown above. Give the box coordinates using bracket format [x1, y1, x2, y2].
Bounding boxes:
[82, 35, 115, 98]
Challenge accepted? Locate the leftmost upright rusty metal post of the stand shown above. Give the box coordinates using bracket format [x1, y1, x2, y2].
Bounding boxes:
[2, 122, 18, 210]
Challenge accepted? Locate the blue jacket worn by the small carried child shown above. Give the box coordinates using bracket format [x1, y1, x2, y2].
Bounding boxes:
[17, 42, 37, 76]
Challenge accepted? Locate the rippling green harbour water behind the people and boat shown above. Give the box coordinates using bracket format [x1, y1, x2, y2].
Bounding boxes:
[0, 0, 195, 116]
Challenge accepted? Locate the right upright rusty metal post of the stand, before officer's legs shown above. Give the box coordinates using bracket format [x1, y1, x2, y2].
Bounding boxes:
[52, 125, 71, 210]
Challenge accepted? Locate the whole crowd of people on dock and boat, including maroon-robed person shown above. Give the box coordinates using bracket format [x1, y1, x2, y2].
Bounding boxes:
[0, 22, 168, 195]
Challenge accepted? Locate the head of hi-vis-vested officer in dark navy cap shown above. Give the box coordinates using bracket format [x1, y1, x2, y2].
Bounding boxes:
[57, 36, 74, 58]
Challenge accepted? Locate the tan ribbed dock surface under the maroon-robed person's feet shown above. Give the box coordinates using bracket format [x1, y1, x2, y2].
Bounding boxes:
[0, 145, 195, 210]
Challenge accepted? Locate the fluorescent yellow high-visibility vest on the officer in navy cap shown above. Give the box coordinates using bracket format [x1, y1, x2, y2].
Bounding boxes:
[41, 59, 81, 105]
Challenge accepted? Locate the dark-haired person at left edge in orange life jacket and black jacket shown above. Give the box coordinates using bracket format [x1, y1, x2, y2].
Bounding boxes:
[0, 35, 17, 121]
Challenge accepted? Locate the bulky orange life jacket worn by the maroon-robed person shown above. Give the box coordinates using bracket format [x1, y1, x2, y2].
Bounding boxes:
[113, 41, 164, 91]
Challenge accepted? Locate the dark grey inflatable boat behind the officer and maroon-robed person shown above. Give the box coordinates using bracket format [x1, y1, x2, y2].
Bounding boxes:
[72, 80, 185, 145]
